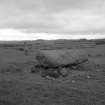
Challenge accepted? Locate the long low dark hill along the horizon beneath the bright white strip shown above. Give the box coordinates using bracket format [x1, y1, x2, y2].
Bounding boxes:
[0, 39, 98, 50]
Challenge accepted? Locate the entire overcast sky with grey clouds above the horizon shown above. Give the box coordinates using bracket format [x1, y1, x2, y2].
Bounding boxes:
[0, 0, 105, 40]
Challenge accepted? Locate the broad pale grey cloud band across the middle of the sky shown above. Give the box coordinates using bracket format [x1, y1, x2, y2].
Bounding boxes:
[0, 10, 105, 33]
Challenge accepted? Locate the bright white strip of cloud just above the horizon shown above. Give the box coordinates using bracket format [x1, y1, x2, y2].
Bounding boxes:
[0, 29, 105, 41]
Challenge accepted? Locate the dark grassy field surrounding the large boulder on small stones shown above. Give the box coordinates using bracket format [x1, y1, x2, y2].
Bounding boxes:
[0, 39, 105, 105]
